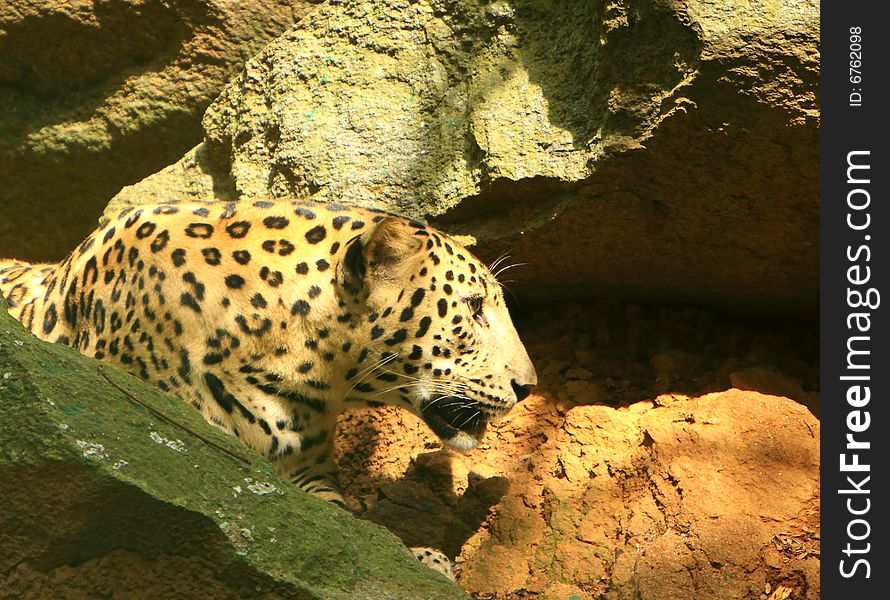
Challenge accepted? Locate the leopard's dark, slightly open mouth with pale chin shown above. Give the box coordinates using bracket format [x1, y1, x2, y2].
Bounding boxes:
[420, 396, 494, 450]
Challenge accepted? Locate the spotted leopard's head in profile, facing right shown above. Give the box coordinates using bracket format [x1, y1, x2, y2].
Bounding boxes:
[338, 216, 537, 449]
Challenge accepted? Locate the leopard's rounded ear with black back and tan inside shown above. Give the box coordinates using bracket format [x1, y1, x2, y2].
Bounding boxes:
[341, 216, 423, 292]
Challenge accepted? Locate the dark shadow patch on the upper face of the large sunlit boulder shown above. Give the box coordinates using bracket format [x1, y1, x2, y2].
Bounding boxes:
[513, 0, 701, 142]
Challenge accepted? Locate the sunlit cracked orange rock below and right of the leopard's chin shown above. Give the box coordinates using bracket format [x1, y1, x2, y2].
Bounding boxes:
[334, 390, 820, 600]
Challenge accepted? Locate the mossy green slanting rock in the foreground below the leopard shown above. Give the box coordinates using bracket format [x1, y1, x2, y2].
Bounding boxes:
[0, 305, 466, 600]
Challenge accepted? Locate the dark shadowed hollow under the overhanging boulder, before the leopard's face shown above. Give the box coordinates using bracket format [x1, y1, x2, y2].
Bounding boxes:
[516, 301, 819, 417]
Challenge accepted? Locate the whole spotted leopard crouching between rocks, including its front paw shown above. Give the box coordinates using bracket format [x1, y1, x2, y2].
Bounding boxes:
[0, 199, 537, 579]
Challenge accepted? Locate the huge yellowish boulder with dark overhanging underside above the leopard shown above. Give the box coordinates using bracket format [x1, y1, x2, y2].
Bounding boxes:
[109, 0, 819, 318]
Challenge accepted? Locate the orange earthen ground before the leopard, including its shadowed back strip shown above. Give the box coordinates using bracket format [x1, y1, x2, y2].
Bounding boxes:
[339, 305, 820, 600]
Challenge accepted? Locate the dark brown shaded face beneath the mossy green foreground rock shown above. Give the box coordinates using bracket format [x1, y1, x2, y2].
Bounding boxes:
[0, 461, 315, 600]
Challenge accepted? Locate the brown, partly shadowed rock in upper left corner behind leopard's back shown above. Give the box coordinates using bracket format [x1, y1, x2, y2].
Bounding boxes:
[0, 0, 313, 260]
